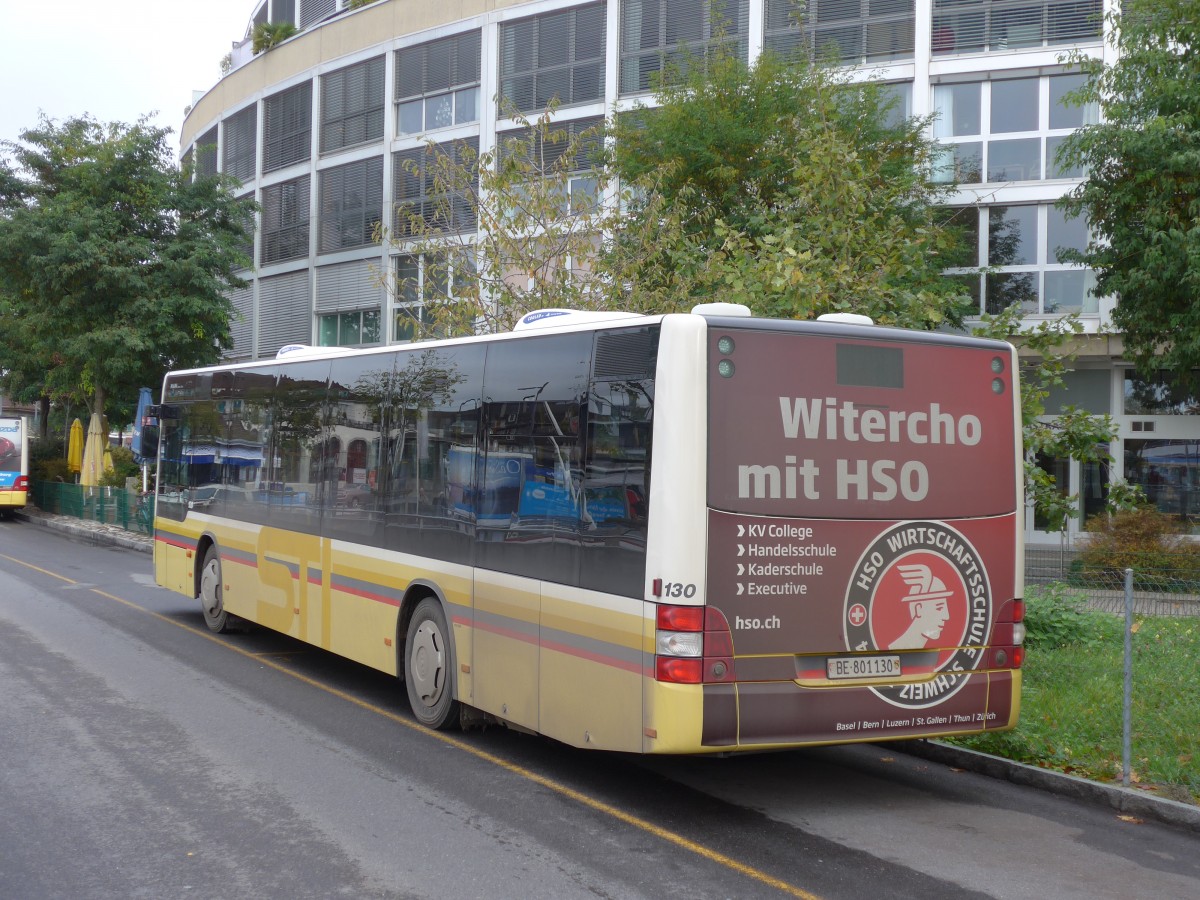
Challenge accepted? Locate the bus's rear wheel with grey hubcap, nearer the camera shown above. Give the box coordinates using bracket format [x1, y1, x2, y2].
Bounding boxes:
[404, 596, 458, 728]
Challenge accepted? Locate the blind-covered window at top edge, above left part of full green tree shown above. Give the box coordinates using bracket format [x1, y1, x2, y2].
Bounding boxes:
[620, 0, 750, 94]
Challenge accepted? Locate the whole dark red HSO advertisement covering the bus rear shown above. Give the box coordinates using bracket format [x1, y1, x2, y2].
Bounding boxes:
[708, 328, 1019, 743]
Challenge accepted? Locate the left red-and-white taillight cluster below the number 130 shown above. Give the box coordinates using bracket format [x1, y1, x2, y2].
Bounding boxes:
[654, 606, 734, 684]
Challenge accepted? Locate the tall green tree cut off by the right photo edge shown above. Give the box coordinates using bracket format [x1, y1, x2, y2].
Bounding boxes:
[1060, 0, 1200, 385]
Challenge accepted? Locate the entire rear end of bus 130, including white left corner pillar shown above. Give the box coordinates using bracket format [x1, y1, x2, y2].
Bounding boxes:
[646, 316, 1024, 752]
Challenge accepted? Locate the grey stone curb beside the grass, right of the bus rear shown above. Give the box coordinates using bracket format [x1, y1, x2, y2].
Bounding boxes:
[893, 740, 1200, 833]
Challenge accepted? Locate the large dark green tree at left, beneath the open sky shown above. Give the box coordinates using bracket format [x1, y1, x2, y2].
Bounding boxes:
[0, 118, 254, 424]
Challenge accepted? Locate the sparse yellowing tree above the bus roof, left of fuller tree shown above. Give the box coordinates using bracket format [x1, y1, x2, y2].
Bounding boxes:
[377, 104, 680, 340]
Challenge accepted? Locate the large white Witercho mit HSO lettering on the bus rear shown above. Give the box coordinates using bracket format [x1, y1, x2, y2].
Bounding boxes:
[738, 397, 983, 502]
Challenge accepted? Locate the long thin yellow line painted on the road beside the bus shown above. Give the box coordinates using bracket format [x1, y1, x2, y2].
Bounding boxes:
[0, 553, 821, 900]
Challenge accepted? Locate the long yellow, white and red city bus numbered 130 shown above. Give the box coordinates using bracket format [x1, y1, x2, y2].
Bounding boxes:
[154, 304, 1025, 754]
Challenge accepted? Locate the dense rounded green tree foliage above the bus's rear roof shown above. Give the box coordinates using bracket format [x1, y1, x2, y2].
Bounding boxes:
[612, 46, 967, 328]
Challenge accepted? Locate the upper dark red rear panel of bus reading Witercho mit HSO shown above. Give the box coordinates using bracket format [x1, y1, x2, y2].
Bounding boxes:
[708, 326, 1016, 520]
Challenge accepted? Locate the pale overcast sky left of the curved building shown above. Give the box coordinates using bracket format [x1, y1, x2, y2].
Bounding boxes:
[0, 0, 254, 148]
